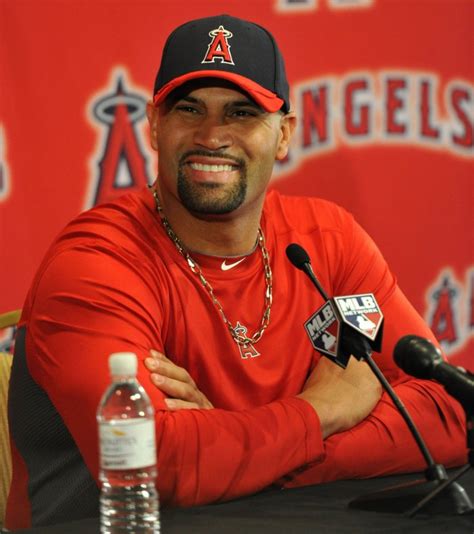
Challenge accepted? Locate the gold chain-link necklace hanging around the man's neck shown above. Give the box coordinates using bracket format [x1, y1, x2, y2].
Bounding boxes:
[152, 188, 273, 347]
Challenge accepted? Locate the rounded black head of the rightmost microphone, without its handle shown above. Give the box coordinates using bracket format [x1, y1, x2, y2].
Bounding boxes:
[393, 335, 442, 379]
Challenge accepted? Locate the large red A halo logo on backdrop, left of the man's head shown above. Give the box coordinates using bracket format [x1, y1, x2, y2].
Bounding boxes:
[86, 68, 153, 208]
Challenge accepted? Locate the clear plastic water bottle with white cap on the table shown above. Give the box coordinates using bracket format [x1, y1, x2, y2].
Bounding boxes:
[97, 352, 160, 534]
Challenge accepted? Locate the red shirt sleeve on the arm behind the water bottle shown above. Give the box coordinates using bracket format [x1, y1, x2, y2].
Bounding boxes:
[25, 244, 323, 505]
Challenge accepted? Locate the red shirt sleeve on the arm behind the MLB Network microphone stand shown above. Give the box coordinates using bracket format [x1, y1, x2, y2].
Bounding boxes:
[286, 216, 467, 487]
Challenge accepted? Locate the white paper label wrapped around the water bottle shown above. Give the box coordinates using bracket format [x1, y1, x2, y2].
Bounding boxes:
[99, 418, 156, 469]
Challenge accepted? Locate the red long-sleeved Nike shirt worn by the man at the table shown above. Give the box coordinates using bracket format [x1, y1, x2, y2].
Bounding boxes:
[7, 189, 466, 528]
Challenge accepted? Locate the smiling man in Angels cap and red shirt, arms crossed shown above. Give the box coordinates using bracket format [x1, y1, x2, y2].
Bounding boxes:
[7, 15, 466, 527]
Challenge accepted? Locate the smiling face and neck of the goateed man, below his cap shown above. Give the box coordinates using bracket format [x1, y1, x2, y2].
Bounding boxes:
[148, 78, 295, 256]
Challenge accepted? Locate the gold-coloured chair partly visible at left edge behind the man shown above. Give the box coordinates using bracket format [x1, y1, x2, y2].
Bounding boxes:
[0, 310, 21, 528]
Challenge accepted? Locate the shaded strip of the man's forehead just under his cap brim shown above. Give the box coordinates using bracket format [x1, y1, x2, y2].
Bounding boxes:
[166, 78, 259, 107]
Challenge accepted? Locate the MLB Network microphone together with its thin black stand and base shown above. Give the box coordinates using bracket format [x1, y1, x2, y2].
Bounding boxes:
[286, 243, 473, 515]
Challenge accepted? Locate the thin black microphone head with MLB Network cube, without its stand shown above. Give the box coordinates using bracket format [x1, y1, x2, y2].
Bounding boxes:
[286, 243, 383, 369]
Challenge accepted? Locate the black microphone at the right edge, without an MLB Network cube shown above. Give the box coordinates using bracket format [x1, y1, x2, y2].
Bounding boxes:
[393, 335, 474, 414]
